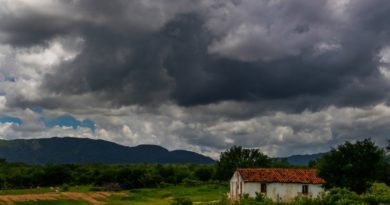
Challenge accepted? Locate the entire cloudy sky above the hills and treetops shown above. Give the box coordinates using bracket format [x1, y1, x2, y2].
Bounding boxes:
[0, 0, 390, 158]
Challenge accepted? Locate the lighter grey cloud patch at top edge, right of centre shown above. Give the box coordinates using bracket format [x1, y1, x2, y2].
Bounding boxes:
[207, 0, 340, 61]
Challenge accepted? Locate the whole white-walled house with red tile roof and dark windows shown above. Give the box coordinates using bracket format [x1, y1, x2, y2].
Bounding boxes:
[229, 168, 325, 201]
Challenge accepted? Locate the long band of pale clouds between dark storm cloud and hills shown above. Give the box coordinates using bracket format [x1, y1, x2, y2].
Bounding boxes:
[0, 100, 390, 158]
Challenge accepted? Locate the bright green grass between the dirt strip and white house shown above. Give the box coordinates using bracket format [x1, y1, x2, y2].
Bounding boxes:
[107, 184, 228, 205]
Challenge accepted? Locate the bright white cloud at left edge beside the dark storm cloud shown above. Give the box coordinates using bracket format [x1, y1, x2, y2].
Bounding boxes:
[0, 37, 83, 108]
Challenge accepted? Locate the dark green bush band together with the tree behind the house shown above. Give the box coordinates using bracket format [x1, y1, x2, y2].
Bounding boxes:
[0, 147, 278, 191]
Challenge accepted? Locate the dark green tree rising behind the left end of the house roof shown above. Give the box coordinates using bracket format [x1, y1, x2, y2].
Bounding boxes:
[216, 146, 271, 180]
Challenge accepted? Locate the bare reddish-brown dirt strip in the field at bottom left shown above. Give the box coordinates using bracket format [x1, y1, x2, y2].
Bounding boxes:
[0, 192, 116, 205]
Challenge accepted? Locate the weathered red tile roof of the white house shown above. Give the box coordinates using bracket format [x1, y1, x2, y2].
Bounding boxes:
[238, 168, 325, 184]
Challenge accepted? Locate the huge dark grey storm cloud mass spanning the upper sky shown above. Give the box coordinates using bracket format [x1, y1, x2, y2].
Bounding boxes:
[0, 0, 390, 111]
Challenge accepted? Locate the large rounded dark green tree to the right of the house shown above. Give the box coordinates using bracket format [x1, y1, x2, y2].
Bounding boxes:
[318, 139, 385, 194]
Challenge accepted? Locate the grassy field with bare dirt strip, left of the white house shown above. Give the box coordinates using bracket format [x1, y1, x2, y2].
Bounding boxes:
[0, 184, 228, 205]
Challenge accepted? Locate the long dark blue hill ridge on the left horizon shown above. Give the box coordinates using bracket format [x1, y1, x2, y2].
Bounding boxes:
[0, 137, 214, 164]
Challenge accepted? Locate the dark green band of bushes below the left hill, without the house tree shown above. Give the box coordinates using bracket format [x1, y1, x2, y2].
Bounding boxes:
[0, 161, 214, 191]
